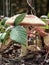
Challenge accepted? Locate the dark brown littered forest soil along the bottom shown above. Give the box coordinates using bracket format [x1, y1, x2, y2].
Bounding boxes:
[0, 45, 49, 65]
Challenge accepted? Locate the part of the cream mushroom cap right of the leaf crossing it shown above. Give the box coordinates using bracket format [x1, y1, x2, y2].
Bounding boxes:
[20, 15, 45, 26]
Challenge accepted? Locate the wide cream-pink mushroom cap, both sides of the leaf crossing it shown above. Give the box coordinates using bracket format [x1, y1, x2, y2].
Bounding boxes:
[5, 14, 46, 26]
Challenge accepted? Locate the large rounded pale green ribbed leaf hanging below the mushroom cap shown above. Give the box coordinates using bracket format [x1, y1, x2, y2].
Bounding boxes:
[10, 26, 27, 45]
